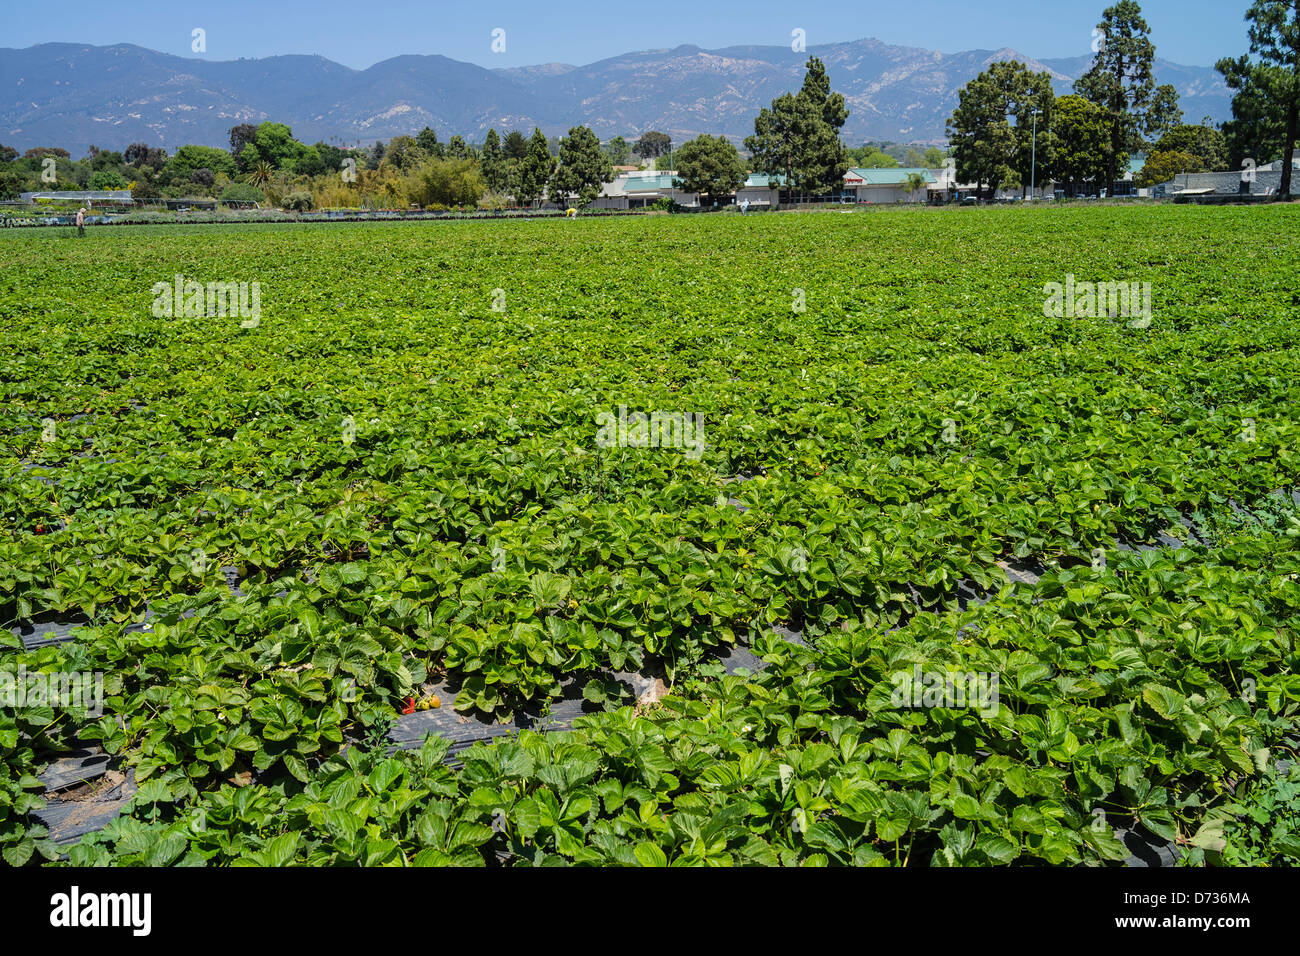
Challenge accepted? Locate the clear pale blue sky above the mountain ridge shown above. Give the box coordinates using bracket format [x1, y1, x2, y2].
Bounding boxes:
[0, 0, 1249, 69]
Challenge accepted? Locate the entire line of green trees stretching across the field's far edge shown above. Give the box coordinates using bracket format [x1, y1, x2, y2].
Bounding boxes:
[0, 0, 1300, 208]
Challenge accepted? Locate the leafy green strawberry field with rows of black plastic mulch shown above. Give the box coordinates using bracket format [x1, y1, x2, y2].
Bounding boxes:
[0, 206, 1300, 866]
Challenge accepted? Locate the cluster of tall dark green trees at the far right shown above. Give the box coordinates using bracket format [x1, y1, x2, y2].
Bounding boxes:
[948, 0, 1300, 196]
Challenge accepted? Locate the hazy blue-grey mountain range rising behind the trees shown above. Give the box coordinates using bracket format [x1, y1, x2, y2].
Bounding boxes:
[0, 39, 1231, 156]
